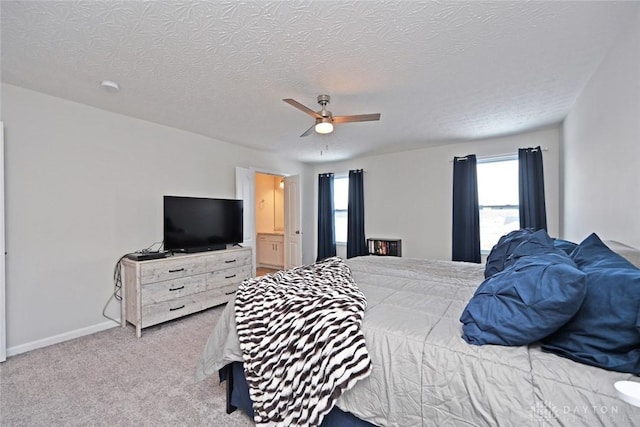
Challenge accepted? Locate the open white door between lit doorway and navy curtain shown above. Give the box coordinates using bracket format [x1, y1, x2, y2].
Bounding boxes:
[284, 175, 302, 268]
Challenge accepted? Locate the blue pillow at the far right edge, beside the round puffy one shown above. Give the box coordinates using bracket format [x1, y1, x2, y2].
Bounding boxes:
[542, 234, 640, 375]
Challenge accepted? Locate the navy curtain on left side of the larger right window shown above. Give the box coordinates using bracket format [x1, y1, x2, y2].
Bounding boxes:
[451, 154, 480, 263]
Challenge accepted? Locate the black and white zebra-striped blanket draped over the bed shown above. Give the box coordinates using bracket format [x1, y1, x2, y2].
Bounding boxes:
[235, 257, 371, 426]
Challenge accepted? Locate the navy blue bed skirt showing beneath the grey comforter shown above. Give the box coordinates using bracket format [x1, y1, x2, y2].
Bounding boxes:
[219, 362, 375, 427]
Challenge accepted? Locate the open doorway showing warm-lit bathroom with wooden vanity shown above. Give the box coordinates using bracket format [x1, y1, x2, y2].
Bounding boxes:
[254, 172, 285, 276]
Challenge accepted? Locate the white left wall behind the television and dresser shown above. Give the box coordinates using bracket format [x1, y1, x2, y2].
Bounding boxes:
[2, 85, 313, 354]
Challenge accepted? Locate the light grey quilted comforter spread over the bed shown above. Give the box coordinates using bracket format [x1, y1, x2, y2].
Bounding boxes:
[196, 236, 640, 426]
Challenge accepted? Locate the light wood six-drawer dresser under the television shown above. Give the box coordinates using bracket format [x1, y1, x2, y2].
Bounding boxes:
[121, 248, 252, 338]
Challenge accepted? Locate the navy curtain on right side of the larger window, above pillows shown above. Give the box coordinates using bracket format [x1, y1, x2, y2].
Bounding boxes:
[518, 147, 547, 230]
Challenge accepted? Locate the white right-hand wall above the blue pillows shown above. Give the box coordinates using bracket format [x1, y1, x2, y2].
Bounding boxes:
[562, 7, 640, 247]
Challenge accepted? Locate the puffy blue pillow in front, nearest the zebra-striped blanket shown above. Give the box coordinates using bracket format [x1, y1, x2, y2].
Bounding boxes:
[460, 251, 585, 346]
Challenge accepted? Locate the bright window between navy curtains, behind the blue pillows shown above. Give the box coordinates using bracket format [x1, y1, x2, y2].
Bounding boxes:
[477, 156, 520, 254]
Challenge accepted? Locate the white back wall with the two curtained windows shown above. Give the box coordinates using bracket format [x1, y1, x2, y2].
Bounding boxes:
[314, 128, 560, 260]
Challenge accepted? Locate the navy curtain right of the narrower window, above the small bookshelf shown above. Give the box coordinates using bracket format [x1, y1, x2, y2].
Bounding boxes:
[347, 169, 369, 258]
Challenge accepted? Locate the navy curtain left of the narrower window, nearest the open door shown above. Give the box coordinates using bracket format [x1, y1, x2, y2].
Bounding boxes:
[317, 173, 336, 261]
